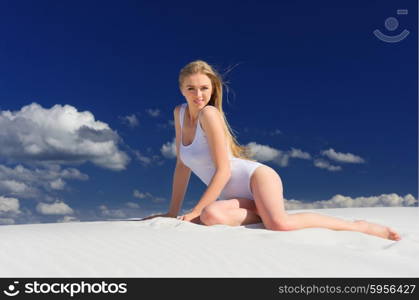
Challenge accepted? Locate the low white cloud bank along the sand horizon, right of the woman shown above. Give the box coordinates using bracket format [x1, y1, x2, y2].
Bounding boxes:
[285, 193, 418, 209]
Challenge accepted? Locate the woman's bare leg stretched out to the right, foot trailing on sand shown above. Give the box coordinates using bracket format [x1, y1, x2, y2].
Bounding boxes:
[251, 166, 400, 240]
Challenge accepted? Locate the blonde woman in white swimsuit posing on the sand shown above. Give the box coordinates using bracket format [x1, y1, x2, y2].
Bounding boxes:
[143, 60, 400, 241]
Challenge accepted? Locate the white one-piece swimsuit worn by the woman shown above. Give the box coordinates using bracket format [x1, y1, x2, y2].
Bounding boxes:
[179, 103, 263, 200]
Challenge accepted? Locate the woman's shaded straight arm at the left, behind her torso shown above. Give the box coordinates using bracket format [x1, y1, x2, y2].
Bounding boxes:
[168, 106, 191, 217]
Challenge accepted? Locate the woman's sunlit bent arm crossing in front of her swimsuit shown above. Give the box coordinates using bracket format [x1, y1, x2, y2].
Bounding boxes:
[185, 105, 231, 217]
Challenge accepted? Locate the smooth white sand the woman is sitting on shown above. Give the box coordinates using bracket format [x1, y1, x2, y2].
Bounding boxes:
[0, 207, 419, 277]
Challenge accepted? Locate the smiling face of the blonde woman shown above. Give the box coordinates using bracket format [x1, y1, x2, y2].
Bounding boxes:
[182, 73, 212, 110]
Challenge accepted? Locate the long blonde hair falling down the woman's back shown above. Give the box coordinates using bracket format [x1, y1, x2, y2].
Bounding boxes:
[179, 60, 255, 161]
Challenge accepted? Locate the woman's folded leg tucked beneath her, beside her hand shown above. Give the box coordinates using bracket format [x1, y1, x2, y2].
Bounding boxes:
[200, 198, 262, 226]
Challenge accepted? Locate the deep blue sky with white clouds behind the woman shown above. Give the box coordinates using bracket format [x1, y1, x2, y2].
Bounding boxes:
[0, 0, 418, 224]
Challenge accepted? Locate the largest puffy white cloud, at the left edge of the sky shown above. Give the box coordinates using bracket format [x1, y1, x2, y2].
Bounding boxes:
[0, 103, 129, 170]
